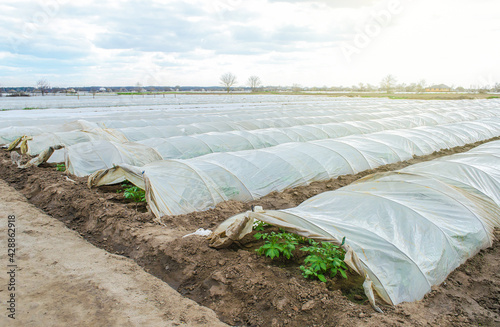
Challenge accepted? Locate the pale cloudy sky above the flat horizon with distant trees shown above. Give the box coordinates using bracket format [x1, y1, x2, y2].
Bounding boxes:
[0, 0, 500, 87]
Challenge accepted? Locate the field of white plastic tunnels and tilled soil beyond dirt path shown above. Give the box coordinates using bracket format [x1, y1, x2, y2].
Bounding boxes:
[0, 95, 500, 326]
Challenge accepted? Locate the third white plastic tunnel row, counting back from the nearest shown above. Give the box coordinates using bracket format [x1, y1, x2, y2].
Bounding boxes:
[58, 116, 500, 177]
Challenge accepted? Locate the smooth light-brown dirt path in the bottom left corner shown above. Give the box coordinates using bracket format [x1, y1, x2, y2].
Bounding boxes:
[0, 180, 225, 326]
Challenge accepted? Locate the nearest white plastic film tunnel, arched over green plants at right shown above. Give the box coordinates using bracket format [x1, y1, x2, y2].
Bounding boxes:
[214, 141, 500, 305]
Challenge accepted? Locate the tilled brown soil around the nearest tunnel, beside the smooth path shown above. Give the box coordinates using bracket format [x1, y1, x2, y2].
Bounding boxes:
[0, 138, 500, 326]
